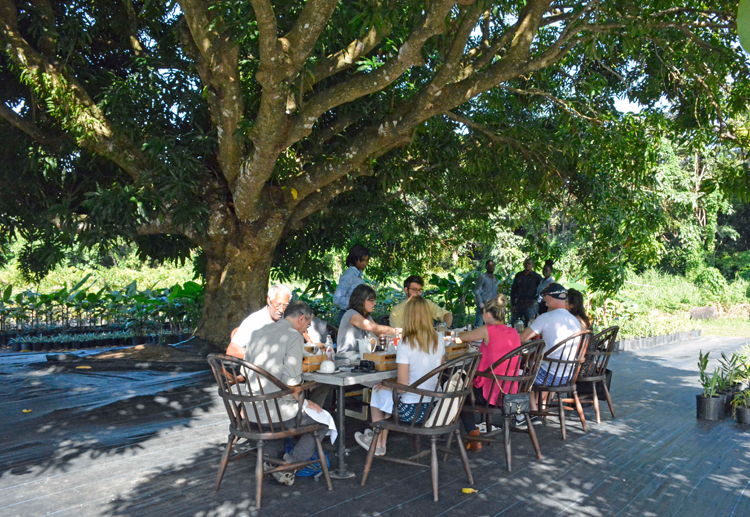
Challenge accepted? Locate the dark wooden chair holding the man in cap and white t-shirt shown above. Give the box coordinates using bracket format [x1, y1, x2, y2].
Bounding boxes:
[531, 330, 591, 440]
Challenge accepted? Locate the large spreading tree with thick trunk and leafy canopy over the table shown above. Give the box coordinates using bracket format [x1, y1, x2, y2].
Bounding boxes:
[0, 0, 750, 341]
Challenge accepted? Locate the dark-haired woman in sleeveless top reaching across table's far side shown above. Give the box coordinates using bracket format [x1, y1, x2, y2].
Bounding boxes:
[336, 284, 396, 354]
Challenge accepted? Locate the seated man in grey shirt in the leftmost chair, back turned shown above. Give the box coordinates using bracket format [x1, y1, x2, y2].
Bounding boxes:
[244, 301, 326, 486]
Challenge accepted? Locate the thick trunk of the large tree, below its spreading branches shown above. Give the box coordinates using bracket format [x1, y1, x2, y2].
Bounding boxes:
[196, 216, 283, 348]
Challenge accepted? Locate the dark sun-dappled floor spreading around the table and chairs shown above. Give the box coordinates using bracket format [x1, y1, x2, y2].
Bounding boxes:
[0, 337, 750, 517]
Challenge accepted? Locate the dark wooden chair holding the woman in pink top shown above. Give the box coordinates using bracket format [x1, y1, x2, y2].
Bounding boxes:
[463, 339, 544, 472]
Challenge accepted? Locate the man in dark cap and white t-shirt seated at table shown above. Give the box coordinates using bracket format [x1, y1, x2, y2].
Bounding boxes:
[521, 283, 581, 416]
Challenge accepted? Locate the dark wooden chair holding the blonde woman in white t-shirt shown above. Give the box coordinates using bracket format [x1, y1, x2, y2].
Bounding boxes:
[362, 352, 482, 501]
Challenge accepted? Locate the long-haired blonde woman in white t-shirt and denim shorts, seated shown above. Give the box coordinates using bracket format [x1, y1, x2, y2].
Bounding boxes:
[354, 296, 445, 456]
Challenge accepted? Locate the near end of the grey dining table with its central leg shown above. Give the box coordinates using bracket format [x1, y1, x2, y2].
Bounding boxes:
[302, 368, 398, 479]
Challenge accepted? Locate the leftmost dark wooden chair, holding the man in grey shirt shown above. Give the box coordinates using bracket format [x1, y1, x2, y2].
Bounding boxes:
[208, 354, 333, 509]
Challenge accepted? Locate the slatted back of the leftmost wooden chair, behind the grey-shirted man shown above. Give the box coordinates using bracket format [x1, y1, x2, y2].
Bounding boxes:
[208, 354, 302, 433]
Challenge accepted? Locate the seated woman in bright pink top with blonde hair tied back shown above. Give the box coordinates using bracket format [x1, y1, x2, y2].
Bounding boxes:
[458, 294, 521, 450]
